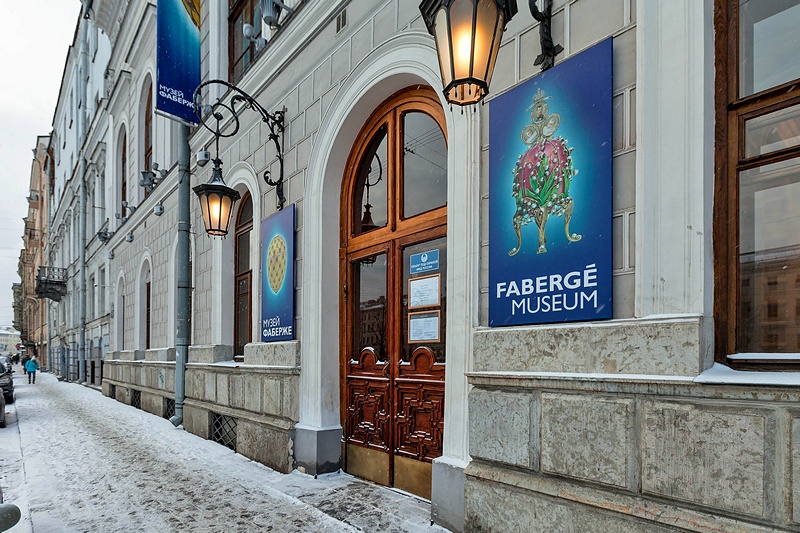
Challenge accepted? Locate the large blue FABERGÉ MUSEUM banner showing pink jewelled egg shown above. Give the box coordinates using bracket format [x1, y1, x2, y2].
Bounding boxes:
[489, 39, 613, 326]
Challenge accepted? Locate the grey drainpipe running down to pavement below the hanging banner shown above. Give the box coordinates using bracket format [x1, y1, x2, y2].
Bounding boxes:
[169, 124, 192, 427]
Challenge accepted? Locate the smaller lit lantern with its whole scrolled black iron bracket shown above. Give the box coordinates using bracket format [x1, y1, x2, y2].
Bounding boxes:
[193, 80, 286, 237]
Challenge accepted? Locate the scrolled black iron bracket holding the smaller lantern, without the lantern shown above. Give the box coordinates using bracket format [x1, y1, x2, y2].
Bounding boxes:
[194, 80, 286, 211]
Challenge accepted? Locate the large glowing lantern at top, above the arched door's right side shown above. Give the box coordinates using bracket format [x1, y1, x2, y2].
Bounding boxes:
[419, 0, 517, 106]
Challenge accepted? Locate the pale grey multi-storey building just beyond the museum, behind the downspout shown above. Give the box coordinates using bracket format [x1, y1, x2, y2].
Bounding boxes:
[42, 5, 113, 385]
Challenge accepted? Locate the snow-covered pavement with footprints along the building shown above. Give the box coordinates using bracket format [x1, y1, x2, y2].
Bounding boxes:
[0, 367, 445, 533]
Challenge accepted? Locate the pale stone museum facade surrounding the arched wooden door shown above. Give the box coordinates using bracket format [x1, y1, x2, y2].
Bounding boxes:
[39, 0, 800, 532]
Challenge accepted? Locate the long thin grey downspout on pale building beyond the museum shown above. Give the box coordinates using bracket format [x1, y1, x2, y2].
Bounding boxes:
[78, 2, 89, 383]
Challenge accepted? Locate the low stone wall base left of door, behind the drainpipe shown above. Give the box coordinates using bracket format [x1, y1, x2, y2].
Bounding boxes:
[103, 342, 300, 472]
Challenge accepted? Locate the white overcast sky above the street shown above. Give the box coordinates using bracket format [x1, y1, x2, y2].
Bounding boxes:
[0, 0, 81, 326]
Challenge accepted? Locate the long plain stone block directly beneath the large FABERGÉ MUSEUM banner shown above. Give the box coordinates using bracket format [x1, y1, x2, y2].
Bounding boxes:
[473, 315, 703, 377]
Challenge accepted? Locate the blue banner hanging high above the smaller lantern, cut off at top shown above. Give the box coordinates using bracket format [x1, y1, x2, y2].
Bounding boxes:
[156, 0, 200, 123]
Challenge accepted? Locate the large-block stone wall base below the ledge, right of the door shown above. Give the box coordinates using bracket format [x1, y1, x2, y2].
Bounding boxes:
[465, 372, 800, 532]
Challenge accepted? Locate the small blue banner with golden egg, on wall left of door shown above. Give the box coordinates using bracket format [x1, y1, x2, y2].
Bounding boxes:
[261, 204, 294, 342]
